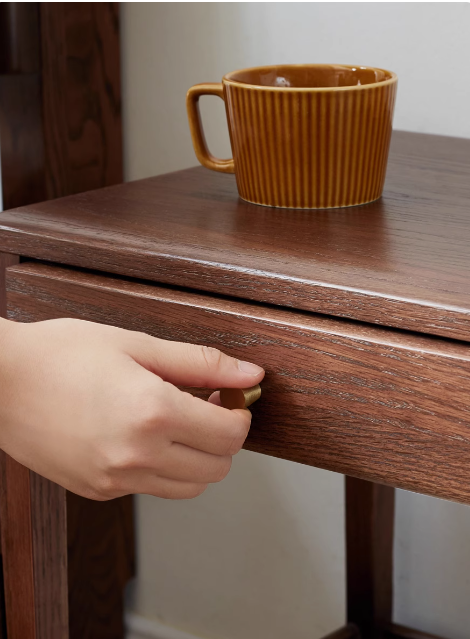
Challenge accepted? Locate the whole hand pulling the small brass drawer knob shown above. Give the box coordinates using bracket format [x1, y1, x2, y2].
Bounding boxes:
[0, 319, 264, 500]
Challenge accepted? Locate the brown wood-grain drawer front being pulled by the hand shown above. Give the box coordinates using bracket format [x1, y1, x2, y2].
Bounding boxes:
[6, 262, 470, 502]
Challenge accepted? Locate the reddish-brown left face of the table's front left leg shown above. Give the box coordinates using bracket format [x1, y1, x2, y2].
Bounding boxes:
[0, 451, 36, 639]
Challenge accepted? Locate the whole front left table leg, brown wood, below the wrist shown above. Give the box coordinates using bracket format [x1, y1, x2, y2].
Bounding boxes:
[0, 451, 69, 639]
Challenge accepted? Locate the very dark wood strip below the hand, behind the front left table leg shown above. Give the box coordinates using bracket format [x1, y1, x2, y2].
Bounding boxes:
[67, 492, 134, 639]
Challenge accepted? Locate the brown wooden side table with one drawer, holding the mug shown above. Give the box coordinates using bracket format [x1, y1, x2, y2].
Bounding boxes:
[0, 133, 470, 639]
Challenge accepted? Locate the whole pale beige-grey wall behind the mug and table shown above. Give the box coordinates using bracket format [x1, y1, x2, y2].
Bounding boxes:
[122, 3, 470, 639]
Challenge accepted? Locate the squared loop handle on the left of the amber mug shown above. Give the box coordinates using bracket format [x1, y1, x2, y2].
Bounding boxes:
[186, 82, 235, 173]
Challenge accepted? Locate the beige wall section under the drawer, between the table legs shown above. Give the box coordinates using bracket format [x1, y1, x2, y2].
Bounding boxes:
[125, 451, 345, 639]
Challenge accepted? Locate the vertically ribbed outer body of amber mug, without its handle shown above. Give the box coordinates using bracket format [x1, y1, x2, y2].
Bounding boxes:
[223, 68, 397, 209]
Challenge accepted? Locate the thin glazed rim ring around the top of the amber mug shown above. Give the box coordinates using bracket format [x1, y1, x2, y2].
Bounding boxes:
[222, 62, 398, 92]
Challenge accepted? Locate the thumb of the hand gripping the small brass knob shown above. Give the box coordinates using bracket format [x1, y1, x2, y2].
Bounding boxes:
[130, 335, 264, 388]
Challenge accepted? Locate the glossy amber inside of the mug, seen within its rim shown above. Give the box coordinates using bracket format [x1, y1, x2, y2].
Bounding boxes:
[223, 64, 396, 89]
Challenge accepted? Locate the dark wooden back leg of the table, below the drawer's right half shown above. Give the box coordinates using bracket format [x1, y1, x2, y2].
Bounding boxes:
[346, 477, 395, 639]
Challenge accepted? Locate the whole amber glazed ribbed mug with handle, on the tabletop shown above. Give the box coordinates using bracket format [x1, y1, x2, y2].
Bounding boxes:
[186, 64, 397, 209]
